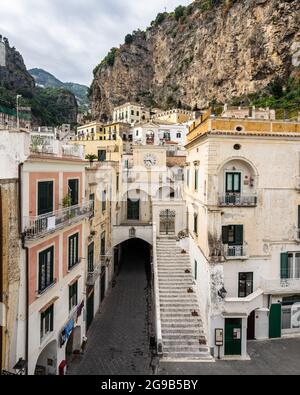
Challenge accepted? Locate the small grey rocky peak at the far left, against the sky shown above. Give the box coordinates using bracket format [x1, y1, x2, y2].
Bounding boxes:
[0, 36, 35, 91]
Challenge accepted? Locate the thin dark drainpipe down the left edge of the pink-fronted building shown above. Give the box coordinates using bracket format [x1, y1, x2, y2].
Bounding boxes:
[18, 163, 29, 376]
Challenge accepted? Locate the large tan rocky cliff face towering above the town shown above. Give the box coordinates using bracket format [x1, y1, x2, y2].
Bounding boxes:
[91, 0, 300, 118]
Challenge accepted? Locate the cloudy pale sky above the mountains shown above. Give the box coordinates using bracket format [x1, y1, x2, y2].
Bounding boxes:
[0, 0, 192, 85]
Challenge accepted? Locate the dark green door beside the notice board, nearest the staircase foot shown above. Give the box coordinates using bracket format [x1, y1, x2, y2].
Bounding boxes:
[225, 318, 242, 355]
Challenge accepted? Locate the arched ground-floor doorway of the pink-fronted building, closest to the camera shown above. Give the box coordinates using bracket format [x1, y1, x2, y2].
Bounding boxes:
[34, 340, 57, 376]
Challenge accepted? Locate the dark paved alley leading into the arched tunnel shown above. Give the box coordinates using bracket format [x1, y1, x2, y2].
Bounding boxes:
[68, 242, 152, 375]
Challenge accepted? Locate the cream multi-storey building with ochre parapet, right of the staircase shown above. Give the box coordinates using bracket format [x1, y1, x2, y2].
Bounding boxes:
[186, 116, 300, 358]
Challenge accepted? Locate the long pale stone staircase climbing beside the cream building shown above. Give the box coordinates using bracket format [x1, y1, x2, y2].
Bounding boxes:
[157, 237, 213, 362]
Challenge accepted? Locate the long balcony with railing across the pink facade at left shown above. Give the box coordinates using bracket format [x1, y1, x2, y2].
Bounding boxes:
[23, 202, 92, 240]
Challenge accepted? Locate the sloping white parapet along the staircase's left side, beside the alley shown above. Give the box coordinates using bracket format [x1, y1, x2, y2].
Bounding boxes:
[152, 222, 163, 355]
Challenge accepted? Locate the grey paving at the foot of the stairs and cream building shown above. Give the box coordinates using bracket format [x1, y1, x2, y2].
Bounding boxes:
[158, 338, 300, 375]
